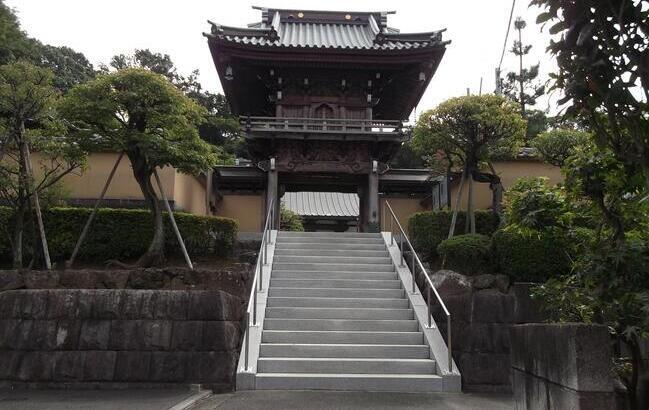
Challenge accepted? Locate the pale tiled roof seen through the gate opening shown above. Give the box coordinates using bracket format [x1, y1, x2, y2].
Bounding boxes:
[282, 192, 358, 217]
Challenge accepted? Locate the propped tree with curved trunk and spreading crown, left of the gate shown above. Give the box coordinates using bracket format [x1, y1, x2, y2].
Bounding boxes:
[61, 68, 218, 266]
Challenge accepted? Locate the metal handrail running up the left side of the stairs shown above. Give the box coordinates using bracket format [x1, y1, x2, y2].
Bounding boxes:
[243, 200, 275, 371]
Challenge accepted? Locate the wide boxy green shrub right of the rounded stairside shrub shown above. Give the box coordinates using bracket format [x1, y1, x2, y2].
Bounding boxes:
[491, 225, 570, 282]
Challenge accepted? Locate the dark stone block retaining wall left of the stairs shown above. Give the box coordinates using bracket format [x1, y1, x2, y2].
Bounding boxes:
[0, 289, 243, 390]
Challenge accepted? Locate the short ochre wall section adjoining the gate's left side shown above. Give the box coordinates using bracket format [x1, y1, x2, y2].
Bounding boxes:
[216, 194, 264, 232]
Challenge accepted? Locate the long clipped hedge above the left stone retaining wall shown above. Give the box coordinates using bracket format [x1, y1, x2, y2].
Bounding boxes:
[0, 208, 238, 262]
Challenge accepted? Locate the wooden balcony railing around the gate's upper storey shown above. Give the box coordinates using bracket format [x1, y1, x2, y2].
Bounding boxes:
[241, 117, 403, 136]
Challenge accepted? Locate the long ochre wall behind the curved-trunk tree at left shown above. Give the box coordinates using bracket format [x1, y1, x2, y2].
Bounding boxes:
[46, 152, 176, 199]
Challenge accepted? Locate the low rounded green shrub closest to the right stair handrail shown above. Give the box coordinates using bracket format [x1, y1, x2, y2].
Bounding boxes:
[437, 234, 491, 275]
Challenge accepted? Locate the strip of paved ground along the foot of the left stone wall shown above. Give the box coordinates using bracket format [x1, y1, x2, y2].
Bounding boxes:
[0, 389, 195, 410]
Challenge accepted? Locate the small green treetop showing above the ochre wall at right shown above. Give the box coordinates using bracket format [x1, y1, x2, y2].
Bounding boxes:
[532, 128, 592, 167]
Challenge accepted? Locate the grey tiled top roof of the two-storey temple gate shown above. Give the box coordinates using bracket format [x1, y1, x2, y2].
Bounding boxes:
[207, 9, 444, 50]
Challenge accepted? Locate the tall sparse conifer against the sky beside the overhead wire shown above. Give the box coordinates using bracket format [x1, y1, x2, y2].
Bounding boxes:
[501, 17, 545, 117]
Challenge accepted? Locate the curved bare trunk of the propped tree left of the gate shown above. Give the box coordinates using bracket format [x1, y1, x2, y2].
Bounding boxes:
[129, 154, 165, 267]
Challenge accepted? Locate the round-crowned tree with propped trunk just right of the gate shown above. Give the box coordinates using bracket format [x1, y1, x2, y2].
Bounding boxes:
[413, 95, 525, 237]
